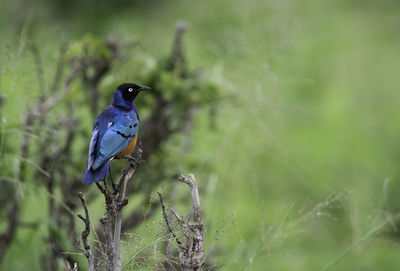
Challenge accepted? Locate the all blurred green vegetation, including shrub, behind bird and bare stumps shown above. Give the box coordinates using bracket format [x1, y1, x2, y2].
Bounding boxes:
[0, 0, 400, 270]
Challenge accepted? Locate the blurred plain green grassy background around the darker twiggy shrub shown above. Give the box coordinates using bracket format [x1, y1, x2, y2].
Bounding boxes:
[0, 0, 400, 270]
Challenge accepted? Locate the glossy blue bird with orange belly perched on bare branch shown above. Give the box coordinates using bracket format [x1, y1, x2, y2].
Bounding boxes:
[83, 83, 151, 185]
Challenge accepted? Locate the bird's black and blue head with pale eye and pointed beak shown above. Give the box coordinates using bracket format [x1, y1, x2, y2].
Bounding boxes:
[113, 83, 151, 109]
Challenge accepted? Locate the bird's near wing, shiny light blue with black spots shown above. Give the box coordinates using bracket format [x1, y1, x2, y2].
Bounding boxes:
[93, 114, 139, 169]
